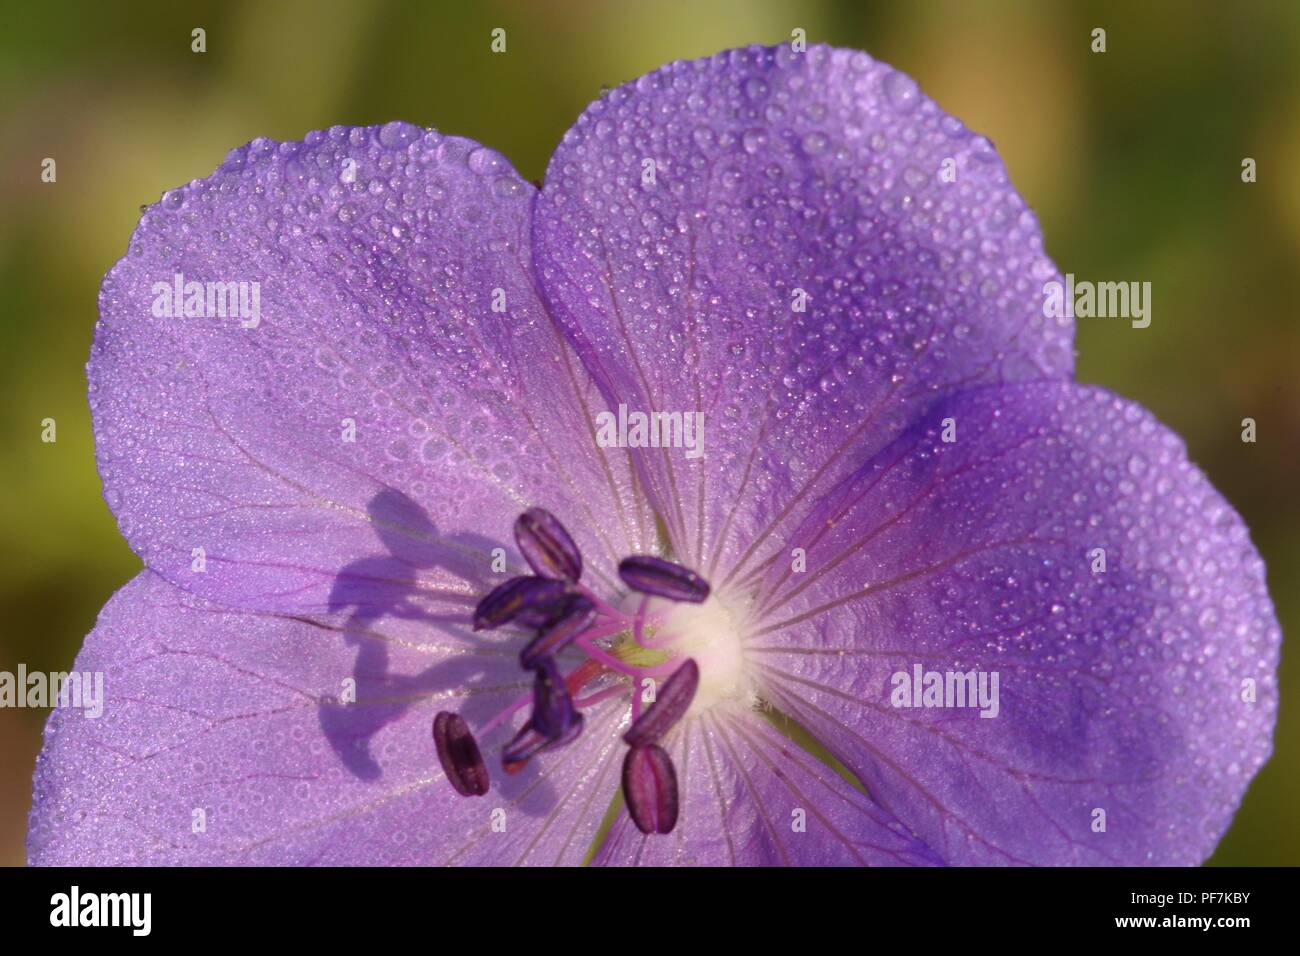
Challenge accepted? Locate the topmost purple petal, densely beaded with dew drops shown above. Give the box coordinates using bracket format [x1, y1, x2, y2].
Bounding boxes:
[534, 47, 1073, 588]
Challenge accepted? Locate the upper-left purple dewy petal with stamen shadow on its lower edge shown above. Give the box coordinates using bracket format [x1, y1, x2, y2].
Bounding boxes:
[88, 124, 654, 615]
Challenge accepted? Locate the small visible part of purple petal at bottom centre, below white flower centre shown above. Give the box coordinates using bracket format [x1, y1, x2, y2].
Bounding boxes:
[594, 711, 939, 866]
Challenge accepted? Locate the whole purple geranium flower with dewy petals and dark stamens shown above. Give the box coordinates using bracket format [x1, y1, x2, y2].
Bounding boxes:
[29, 48, 1281, 864]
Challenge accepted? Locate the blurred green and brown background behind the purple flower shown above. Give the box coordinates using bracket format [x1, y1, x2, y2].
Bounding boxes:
[0, 0, 1300, 864]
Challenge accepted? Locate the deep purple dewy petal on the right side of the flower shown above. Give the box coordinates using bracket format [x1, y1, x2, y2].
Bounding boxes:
[746, 384, 1281, 865]
